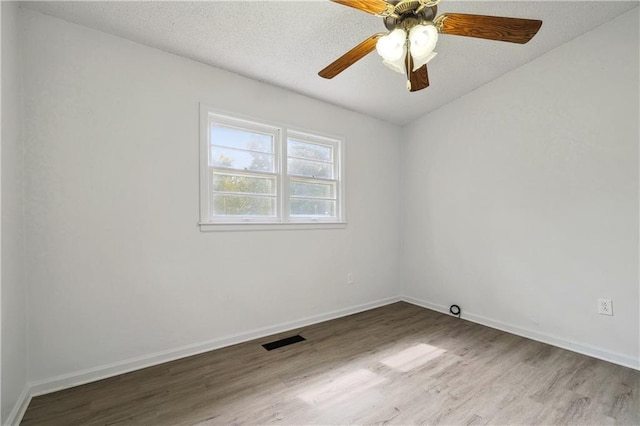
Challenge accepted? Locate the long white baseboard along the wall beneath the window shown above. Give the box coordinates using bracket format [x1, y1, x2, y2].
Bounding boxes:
[29, 296, 401, 396]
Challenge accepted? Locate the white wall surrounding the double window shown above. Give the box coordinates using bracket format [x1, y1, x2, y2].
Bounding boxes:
[22, 11, 400, 388]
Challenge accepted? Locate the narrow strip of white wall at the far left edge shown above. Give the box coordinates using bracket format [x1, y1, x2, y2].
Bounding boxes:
[0, 2, 27, 424]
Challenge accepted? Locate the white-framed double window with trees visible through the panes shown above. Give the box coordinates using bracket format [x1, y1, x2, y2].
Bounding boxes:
[200, 106, 344, 230]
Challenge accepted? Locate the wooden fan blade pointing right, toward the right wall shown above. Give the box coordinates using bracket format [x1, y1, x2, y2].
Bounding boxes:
[435, 13, 542, 44]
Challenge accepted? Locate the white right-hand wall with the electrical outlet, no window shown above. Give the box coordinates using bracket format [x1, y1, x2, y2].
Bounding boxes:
[401, 8, 640, 368]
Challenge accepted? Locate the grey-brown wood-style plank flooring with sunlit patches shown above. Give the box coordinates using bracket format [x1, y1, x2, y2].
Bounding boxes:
[22, 303, 640, 425]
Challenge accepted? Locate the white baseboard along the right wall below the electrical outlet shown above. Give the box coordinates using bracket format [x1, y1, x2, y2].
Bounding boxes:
[402, 296, 640, 370]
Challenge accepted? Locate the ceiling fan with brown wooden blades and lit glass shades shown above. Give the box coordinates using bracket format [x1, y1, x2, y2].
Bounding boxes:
[318, 0, 542, 92]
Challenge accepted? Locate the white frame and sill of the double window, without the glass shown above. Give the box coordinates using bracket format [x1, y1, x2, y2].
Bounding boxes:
[199, 104, 346, 231]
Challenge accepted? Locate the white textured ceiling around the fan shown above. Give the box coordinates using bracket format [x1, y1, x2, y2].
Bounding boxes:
[23, 0, 638, 125]
